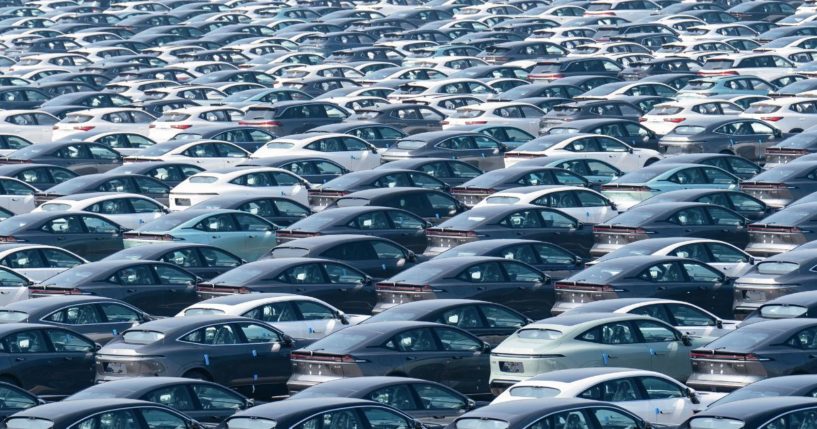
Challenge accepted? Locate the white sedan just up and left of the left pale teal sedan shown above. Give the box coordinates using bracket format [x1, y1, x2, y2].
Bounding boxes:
[33, 192, 170, 229]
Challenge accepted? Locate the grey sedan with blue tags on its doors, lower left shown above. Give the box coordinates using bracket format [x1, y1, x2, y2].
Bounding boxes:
[96, 314, 293, 397]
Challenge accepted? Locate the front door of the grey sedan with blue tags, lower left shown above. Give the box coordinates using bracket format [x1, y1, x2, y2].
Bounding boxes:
[233, 322, 292, 395]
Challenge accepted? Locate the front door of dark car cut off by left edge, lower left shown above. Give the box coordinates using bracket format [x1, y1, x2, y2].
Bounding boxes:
[43, 328, 96, 395]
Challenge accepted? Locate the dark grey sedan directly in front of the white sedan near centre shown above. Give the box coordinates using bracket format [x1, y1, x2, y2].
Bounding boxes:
[424, 204, 593, 257]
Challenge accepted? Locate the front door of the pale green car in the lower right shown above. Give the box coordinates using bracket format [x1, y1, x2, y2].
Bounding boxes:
[634, 320, 692, 380]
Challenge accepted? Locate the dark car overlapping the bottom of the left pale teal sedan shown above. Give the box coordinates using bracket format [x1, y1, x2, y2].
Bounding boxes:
[104, 242, 246, 280]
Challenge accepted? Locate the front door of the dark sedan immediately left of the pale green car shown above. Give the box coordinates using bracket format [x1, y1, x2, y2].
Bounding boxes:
[432, 327, 489, 394]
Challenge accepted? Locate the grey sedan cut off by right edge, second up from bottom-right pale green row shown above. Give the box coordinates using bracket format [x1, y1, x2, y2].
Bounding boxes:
[733, 249, 817, 316]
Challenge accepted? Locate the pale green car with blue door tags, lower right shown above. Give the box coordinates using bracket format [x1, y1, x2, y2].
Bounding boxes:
[490, 313, 709, 394]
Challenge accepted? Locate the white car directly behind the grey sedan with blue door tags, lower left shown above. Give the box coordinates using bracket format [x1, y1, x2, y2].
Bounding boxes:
[176, 293, 369, 340]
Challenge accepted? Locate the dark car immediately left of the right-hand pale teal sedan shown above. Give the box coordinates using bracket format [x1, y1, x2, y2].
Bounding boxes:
[451, 166, 590, 207]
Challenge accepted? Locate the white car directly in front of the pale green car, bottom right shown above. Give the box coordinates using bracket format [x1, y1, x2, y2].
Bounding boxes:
[491, 367, 700, 427]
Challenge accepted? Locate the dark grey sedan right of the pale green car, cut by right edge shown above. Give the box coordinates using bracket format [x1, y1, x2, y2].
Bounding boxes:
[687, 318, 817, 392]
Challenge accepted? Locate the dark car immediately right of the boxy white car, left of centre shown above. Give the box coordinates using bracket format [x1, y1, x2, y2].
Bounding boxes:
[308, 168, 449, 210]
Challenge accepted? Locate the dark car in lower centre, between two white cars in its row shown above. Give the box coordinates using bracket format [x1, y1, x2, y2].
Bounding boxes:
[361, 298, 533, 346]
